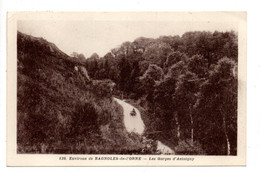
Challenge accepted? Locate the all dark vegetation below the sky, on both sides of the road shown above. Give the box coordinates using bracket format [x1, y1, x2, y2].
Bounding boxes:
[17, 31, 238, 155]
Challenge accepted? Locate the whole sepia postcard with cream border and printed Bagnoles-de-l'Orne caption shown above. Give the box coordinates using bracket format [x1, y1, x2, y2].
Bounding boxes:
[7, 12, 247, 166]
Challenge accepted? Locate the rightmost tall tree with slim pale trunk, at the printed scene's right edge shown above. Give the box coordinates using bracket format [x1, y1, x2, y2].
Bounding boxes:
[198, 57, 237, 155]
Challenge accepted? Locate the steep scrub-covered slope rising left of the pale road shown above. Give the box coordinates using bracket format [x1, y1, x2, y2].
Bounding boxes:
[17, 32, 154, 154]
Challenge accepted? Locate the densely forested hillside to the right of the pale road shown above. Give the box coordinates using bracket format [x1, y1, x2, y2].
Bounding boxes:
[85, 31, 238, 155]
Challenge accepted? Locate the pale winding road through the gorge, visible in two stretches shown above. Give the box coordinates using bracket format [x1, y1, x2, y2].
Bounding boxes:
[114, 98, 175, 155]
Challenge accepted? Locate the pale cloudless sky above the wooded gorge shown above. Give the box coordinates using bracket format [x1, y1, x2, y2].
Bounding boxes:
[17, 20, 237, 57]
